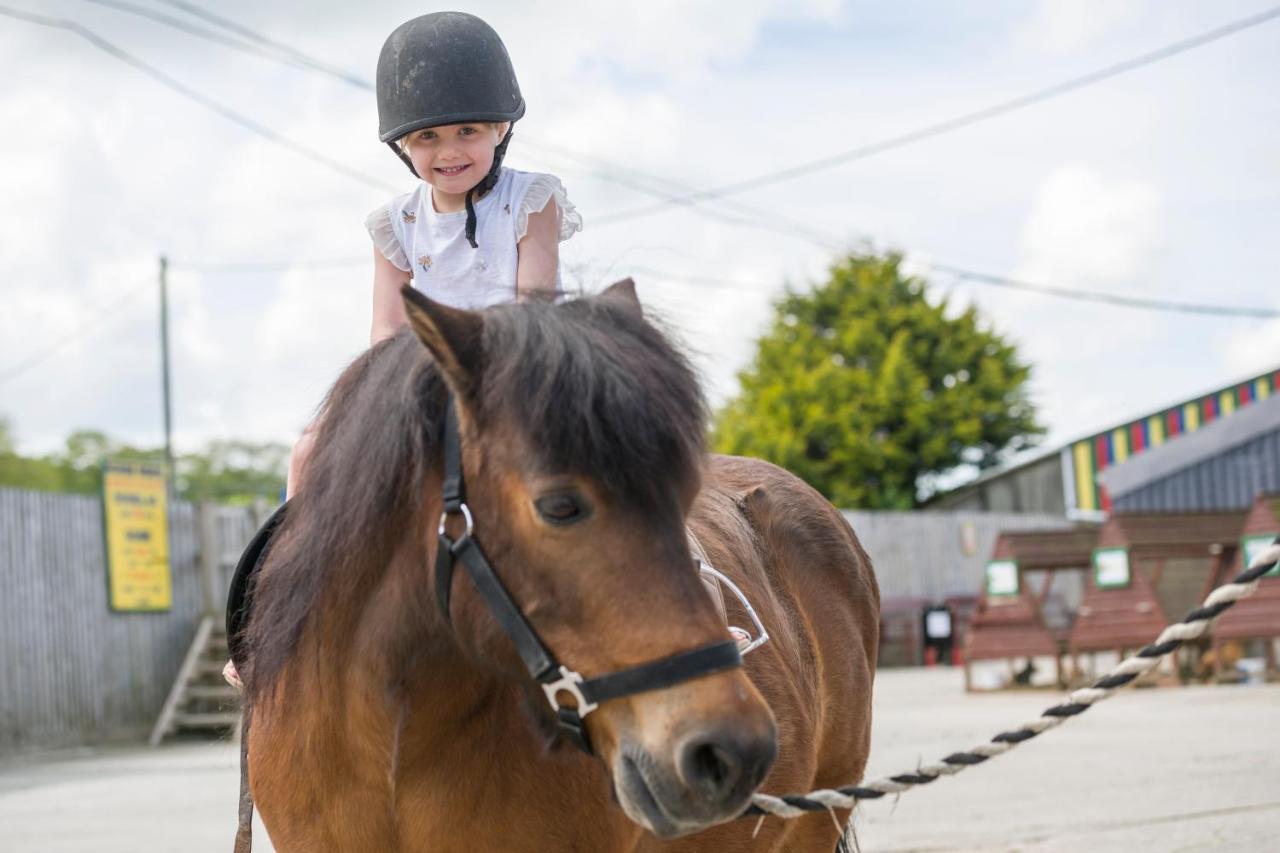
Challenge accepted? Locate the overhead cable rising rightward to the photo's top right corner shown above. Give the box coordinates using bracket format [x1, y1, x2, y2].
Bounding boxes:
[593, 6, 1280, 227]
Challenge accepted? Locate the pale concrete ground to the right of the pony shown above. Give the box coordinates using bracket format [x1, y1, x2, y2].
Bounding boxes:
[856, 670, 1280, 853]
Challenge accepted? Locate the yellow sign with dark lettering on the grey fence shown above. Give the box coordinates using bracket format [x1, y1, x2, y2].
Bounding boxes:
[102, 461, 173, 611]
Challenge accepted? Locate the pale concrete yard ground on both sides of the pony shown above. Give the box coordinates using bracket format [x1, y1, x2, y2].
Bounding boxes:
[0, 670, 1280, 853]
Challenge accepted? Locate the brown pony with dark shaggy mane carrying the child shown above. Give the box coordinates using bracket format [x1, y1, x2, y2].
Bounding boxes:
[242, 282, 879, 853]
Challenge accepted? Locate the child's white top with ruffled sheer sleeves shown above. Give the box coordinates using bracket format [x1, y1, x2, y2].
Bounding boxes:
[365, 168, 582, 309]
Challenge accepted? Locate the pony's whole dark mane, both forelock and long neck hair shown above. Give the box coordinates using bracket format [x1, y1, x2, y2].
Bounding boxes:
[244, 296, 707, 693]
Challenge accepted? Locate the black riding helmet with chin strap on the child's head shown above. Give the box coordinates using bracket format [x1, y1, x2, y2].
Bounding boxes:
[378, 12, 525, 248]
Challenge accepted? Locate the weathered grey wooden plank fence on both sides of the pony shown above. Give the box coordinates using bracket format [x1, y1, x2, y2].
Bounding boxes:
[0, 488, 1066, 756]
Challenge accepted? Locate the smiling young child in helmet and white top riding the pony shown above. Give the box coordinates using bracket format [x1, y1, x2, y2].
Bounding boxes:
[224, 12, 582, 686]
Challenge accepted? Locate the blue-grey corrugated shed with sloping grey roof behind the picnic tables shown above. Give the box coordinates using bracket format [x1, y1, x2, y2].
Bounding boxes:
[1101, 396, 1280, 512]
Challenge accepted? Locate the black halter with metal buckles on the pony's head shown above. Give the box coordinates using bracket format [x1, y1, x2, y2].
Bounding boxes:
[435, 396, 742, 754]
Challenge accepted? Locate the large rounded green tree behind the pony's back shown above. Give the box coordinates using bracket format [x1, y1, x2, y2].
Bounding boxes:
[714, 254, 1043, 508]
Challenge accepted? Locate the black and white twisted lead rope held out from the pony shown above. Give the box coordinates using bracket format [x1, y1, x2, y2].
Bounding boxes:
[746, 537, 1280, 818]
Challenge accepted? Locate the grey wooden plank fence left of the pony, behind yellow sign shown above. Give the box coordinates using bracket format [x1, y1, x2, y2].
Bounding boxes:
[0, 488, 257, 756]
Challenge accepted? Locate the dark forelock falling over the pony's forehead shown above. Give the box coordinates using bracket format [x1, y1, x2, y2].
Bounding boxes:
[480, 297, 707, 507]
